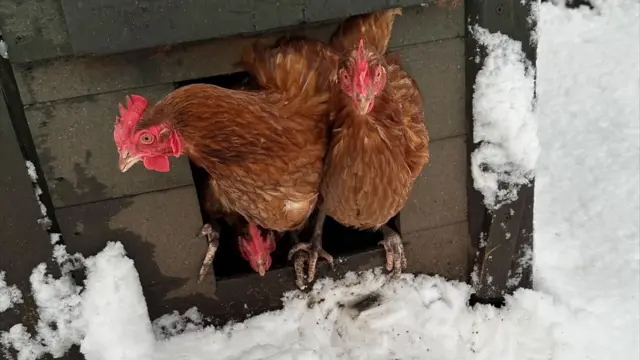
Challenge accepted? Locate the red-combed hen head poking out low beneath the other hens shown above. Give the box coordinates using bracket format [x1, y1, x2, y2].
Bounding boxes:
[238, 222, 276, 276]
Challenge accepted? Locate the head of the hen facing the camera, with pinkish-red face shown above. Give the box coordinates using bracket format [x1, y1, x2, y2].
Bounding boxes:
[338, 40, 387, 115]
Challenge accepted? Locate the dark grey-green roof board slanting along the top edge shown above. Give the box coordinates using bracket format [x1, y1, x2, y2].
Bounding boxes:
[0, 0, 435, 63]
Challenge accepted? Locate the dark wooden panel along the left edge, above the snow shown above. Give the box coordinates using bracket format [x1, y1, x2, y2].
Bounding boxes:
[0, 48, 83, 360]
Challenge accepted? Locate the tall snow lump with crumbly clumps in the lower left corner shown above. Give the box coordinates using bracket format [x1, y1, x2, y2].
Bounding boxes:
[0, 243, 155, 360]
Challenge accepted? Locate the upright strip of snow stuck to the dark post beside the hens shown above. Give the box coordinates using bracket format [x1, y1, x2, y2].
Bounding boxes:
[471, 26, 540, 210]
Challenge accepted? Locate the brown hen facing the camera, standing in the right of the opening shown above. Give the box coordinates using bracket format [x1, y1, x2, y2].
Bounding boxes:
[290, 9, 429, 286]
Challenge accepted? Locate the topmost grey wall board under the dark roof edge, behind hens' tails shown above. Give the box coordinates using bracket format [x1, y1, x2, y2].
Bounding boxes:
[14, 6, 464, 104]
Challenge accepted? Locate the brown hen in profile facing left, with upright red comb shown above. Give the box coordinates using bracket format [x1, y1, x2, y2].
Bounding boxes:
[114, 38, 337, 282]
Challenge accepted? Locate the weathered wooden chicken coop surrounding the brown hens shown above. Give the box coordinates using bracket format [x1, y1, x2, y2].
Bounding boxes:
[0, 0, 535, 332]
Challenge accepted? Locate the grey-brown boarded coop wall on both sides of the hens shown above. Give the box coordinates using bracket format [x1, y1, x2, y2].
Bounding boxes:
[8, 3, 468, 314]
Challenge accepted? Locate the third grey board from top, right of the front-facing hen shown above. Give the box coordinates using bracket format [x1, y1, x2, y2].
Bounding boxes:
[400, 136, 467, 234]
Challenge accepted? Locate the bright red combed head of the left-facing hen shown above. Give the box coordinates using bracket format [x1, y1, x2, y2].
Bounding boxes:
[113, 95, 182, 172]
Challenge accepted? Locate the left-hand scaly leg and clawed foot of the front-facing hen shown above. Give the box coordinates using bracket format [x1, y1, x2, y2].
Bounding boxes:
[289, 207, 333, 289]
